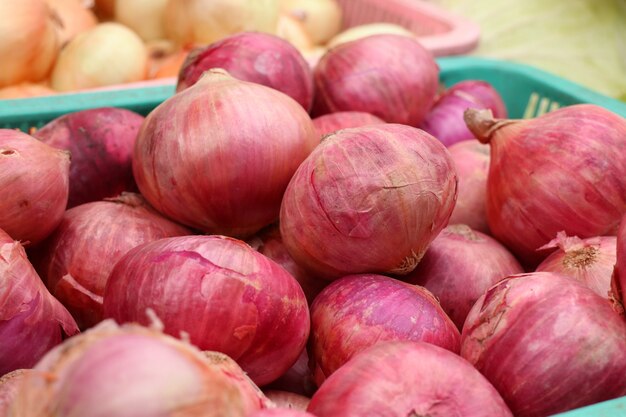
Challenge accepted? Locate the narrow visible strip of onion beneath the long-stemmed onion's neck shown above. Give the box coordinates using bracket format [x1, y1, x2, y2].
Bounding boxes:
[448, 139, 490, 234]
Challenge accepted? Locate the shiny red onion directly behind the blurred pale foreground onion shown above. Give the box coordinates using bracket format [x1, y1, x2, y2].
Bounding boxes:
[104, 236, 310, 386]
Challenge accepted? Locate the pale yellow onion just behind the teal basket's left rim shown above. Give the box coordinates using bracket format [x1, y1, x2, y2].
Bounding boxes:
[51, 23, 148, 91]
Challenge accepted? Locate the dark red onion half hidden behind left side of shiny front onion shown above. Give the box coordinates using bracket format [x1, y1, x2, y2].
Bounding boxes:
[33, 193, 191, 329]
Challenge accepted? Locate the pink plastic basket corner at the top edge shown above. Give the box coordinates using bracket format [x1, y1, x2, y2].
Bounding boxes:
[338, 0, 480, 56]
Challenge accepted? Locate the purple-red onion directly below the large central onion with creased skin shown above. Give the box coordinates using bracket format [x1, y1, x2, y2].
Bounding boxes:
[308, 274, 460, 386]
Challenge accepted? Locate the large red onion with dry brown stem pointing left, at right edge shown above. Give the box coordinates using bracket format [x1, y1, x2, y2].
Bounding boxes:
[466, 104, 626, 266]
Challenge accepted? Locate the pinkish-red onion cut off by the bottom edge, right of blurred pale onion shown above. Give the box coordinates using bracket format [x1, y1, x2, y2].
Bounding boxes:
[307, 341, 513, 417]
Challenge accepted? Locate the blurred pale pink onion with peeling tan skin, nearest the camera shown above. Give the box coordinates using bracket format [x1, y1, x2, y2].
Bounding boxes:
[9, 321, 263, 417]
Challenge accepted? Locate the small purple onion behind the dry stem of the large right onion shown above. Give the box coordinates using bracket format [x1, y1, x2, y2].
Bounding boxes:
[420, 80, 507, 146]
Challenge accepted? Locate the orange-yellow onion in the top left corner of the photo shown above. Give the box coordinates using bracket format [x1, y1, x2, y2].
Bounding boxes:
[0, 0, 60, 87]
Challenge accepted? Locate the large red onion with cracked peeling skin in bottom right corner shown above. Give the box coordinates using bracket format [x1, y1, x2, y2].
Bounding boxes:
[461, 272, 626, 417]
